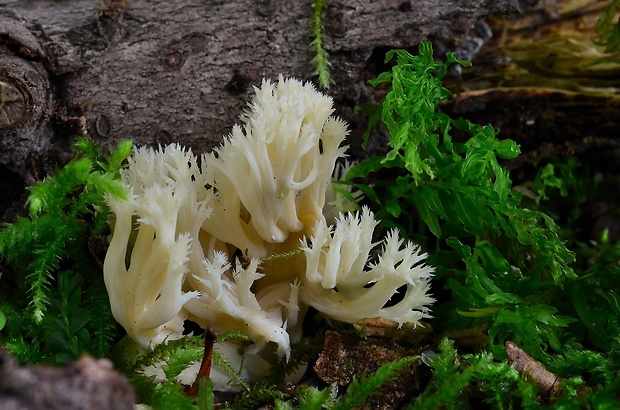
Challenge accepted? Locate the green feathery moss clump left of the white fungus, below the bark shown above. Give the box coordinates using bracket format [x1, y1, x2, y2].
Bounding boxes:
[0, 138, 131, 362]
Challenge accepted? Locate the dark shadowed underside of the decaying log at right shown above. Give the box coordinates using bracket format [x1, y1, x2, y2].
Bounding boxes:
[442, 87, 620, 172]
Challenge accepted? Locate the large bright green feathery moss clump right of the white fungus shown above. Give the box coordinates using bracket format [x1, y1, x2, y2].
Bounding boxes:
[346, 42, 576, 359]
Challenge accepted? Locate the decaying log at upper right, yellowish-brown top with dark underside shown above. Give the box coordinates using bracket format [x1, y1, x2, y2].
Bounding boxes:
[442, 0, 620, 174]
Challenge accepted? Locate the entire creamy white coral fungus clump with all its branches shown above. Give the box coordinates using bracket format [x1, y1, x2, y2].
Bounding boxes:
[104, 77, 433, 388]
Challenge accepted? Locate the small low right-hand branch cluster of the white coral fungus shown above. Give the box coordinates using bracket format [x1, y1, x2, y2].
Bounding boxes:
[301, 208, 433, 325]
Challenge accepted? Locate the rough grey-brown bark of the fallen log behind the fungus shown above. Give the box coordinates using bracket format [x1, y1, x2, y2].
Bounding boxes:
[0, 0, 536, 187]
